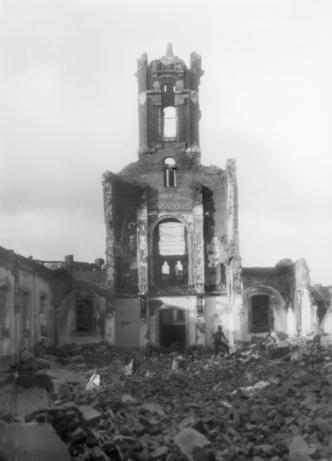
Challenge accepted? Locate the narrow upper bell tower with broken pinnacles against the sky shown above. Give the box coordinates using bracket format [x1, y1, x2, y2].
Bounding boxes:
[136, 43, 204, 153]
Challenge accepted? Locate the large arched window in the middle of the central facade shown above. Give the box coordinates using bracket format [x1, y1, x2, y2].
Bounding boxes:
[154, 219, 188, 287]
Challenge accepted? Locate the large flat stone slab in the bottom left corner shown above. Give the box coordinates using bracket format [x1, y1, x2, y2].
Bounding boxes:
[0, 423, 72, 461]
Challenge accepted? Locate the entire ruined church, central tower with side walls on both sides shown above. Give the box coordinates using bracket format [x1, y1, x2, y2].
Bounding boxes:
[0, 45, 332, 369]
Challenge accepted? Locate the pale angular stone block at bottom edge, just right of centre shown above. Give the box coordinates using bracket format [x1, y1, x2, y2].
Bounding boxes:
[174, 428, 210, 461]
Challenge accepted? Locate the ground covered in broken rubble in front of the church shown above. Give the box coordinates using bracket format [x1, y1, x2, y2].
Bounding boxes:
[0, 334, 332, 461]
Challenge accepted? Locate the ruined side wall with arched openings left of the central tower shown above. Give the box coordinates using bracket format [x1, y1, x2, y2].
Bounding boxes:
[0, 247, 107, 369]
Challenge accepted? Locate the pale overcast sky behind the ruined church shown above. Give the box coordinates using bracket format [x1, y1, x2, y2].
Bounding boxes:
[0, 0, 332, 284]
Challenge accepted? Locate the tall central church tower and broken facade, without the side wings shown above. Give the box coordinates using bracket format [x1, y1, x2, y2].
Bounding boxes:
[103, 45, 242, 345]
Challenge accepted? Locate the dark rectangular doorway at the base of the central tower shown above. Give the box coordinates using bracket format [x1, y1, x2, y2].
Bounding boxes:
[160, 309, 186, 351]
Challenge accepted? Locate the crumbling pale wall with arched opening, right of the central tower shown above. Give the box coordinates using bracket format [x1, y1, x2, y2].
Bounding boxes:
[242, 259, 319, 336]
